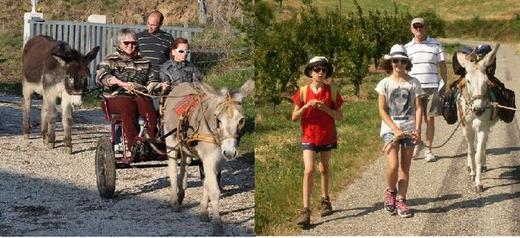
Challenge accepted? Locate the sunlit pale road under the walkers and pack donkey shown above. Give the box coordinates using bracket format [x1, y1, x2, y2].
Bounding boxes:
[303, 42, 520, 236]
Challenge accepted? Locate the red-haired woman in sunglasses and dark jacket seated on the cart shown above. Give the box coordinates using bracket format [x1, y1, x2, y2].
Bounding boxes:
[159, 37, 202, 85]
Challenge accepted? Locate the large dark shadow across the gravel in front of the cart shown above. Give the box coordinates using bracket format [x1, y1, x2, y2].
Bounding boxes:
[0, 171, 234, 236]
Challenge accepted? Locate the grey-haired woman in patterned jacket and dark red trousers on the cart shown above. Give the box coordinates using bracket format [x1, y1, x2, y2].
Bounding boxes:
[96, 28, 168, 151]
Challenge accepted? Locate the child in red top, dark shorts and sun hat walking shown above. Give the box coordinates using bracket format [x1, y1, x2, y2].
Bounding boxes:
[291, 56, 343, 227]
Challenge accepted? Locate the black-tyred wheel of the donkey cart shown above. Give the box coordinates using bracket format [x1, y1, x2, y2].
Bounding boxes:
[96, 137, 116, 198]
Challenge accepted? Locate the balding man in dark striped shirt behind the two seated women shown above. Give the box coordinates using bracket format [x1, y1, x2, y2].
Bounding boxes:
[137, 10, 173, 79]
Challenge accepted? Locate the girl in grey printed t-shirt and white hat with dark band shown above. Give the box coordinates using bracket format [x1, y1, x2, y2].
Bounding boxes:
[375, 45, 423, 217]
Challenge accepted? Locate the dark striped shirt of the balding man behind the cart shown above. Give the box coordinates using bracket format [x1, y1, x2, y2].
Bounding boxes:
[136, 30, 173, 79]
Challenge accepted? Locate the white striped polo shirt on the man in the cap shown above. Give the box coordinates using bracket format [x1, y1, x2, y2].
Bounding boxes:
[404, 37, 446, 88]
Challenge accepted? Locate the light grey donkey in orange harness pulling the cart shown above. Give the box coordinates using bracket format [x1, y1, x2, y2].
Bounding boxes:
[164, 80, 254, 234]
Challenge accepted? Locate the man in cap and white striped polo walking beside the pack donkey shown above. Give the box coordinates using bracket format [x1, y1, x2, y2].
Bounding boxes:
[405, 17, 447, 162]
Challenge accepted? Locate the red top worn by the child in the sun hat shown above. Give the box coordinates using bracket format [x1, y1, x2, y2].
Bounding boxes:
[293, 84, 343, 146]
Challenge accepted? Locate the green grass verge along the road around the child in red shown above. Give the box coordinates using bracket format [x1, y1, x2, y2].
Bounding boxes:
[255, 75, 383, 235]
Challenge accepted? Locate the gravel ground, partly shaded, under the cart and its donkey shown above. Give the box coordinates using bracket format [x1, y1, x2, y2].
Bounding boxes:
[0, 95, 255, 236]
